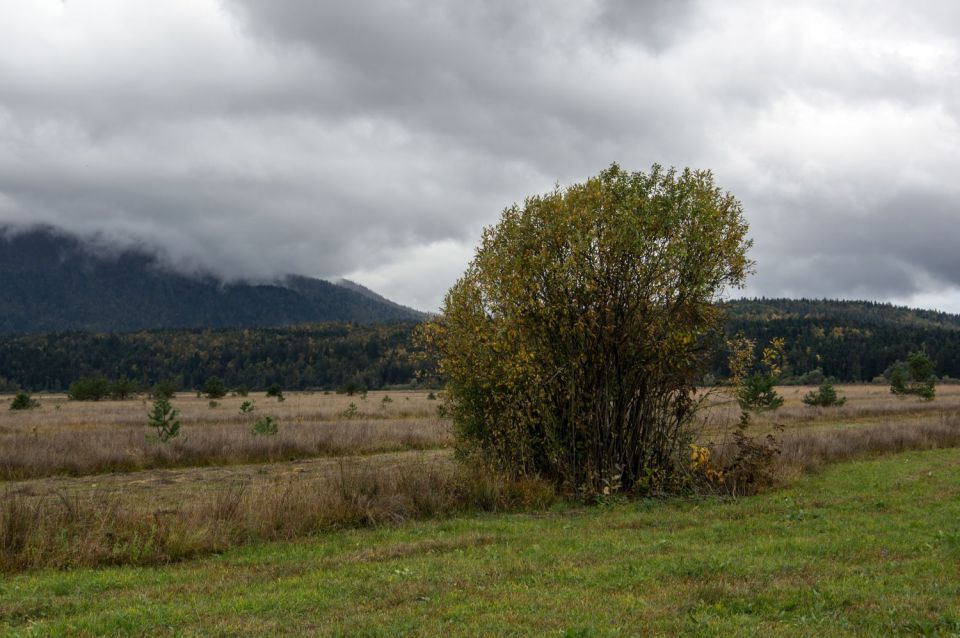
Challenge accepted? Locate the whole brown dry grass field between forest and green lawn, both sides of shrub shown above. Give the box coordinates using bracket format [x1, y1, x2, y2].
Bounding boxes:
[0, 386, 960, 570]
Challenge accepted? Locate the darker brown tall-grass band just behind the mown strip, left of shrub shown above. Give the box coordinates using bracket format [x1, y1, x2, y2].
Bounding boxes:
[0, 419, 453, 480]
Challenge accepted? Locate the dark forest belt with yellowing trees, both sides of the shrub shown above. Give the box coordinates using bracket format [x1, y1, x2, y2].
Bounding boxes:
[0, 299, 960, 390]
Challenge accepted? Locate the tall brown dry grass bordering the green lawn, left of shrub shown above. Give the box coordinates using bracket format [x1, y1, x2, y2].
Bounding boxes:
[0, 463, 554, 572]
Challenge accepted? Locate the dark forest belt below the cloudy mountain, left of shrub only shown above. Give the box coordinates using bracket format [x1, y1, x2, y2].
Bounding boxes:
[0, 323, 424, 390]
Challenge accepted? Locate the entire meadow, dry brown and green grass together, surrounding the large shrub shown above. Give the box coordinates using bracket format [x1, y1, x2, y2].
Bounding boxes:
[0, 385, 960, 635]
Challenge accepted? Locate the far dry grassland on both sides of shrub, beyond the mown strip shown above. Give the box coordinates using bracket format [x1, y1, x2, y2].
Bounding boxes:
[0, 385, 960, 481]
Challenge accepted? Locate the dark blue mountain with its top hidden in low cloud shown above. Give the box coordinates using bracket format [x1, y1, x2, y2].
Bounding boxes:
[0, 227, 424, 334]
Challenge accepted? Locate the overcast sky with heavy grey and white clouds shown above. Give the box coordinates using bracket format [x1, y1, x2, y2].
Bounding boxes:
[0, 0, 960, 312]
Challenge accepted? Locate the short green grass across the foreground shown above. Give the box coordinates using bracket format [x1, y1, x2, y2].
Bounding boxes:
[0, 450, 960, 636]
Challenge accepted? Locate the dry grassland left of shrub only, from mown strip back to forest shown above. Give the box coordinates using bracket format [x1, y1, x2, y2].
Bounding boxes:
[0, 392, 452, 482]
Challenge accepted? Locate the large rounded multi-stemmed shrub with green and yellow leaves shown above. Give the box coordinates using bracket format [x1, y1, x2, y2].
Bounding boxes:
[425, 165, 749, 491]
